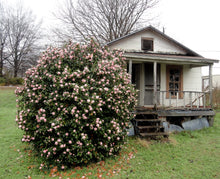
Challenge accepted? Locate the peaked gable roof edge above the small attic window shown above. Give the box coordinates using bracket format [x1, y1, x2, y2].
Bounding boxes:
[106, 26, 202, 57]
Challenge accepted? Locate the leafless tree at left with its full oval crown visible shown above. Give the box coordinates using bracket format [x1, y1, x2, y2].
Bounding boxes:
[7, 2, 41, 77]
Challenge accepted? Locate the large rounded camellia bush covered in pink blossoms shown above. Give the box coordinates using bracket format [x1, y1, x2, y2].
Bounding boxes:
[16, 41, 137, 169]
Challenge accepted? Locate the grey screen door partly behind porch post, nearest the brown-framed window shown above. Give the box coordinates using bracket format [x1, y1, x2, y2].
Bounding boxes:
[144, 63, 160, 105]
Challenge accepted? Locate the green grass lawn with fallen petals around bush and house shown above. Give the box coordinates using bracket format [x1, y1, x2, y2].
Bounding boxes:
[0, 88, 220, 179]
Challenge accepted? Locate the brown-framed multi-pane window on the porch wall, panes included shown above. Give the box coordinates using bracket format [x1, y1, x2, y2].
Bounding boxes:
[167, 65, 183, 98]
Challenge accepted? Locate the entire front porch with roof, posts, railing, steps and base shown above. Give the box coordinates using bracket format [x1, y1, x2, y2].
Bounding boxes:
[126, 53, 217, 138]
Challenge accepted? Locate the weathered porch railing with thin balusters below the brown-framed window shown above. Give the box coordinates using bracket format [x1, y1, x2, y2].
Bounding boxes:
[156, 91, 211, 108]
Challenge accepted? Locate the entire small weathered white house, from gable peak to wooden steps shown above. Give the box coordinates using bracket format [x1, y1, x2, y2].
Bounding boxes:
[107, 26, 218, 137]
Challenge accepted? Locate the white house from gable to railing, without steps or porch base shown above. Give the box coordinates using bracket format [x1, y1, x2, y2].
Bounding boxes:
[107, 26, 218, 106]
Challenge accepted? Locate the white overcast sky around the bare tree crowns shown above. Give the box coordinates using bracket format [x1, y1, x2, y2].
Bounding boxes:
[3, 0, 220, 75]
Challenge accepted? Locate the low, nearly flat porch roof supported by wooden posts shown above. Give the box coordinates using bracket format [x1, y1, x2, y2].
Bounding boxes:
[123, 52, 219, 67]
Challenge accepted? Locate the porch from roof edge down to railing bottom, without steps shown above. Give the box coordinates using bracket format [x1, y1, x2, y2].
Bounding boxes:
[127, 52, 215, 108]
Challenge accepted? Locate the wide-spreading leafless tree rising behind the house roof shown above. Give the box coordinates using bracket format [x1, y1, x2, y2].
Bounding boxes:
[54, 0, 158, 43]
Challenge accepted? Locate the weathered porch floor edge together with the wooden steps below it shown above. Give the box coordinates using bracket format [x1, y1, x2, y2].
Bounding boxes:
[132, 106, 215, 137]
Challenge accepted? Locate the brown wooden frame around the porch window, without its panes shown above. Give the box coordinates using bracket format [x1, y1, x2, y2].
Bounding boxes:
[166, 65, 183, 99]
